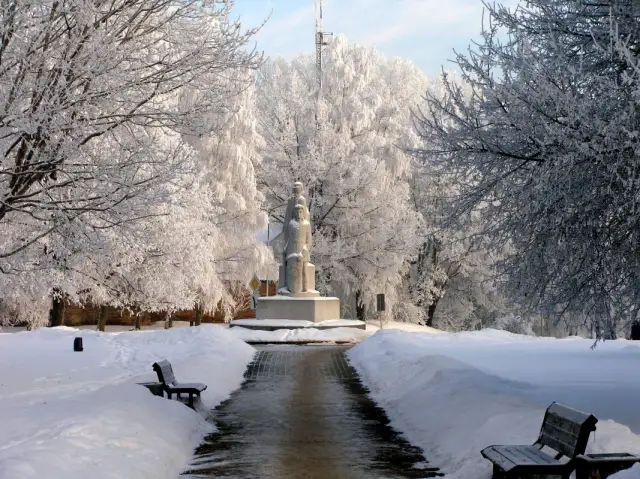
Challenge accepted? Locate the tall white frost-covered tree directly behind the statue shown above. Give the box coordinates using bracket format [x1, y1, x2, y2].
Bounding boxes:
[257, 37, 427, 318]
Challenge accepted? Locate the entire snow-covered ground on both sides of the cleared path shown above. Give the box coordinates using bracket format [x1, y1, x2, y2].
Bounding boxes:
[0, 323, 640, 479]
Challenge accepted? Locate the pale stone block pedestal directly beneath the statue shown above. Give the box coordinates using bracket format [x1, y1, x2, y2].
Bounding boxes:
[256, 295, 340, 323]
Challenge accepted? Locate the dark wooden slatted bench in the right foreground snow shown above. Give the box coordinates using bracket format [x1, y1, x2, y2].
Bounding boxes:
[482, 402, 598, 479]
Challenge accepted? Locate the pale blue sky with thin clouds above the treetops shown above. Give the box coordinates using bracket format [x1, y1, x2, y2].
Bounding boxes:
[234, 0, 492, 75]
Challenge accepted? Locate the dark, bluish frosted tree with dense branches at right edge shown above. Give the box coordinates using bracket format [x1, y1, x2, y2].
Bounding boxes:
[412, 0, 640, 337]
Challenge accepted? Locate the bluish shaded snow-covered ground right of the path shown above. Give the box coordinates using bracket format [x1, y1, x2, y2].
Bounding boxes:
[350, 330, 640, 479]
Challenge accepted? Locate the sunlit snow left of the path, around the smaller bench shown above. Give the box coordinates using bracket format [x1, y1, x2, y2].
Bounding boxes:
[0, 325, 254, 479]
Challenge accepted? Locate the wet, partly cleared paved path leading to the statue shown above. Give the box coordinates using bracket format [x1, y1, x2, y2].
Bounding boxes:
[180, 346, 434, 479]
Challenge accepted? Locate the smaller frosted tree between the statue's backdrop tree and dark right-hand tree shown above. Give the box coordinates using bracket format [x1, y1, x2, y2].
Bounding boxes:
[403, 166, 506, 331]
